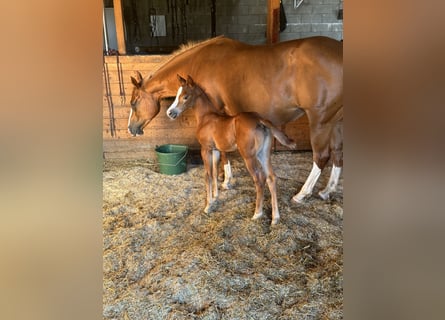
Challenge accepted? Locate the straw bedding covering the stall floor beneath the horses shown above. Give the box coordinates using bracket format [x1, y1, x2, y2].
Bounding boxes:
[103, 152, 343, 320]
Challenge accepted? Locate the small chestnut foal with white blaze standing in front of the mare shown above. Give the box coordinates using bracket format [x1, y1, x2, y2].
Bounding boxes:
[167, 75, 296, 224]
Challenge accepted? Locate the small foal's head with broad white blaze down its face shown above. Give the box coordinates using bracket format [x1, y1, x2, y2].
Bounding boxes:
[167, 75, 204, 119]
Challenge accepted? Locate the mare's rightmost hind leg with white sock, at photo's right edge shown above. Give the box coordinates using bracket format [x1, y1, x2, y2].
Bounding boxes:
[318, 121, 343, 200]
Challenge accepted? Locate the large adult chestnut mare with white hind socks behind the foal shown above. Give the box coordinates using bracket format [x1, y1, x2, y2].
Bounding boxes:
[128, 36, 343, 202]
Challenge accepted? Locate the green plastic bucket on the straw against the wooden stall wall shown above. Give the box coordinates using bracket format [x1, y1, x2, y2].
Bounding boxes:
[155, 144, 188, 175]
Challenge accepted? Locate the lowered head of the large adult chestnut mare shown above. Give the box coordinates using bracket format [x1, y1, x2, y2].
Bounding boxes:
[128, 71, 160, 136]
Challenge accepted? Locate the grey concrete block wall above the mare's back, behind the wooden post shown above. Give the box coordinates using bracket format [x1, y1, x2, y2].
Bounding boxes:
[216, 0, 343, 44]
